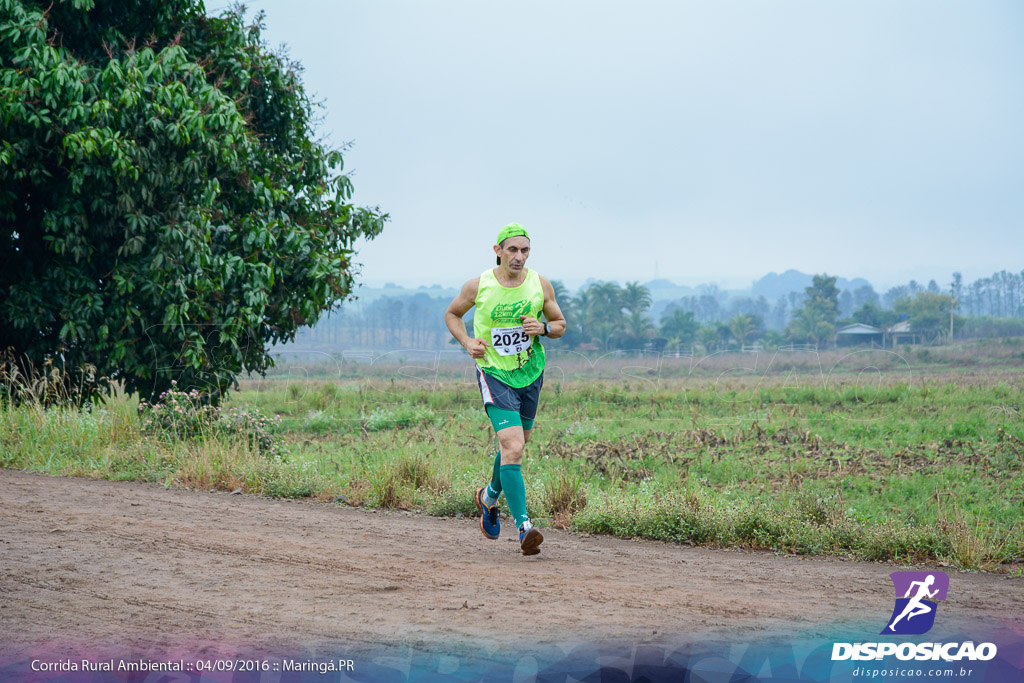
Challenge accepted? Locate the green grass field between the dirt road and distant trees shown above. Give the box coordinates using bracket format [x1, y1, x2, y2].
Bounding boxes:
[0, 343, 1024, 575]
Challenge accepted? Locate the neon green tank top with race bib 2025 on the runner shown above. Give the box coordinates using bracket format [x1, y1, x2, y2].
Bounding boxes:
[473, 268, 544, 388]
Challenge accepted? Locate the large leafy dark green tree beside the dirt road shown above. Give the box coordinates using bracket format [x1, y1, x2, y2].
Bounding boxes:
[0, 0, 386, 400]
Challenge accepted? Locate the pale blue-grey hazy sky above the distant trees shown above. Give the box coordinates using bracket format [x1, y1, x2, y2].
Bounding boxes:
[224, 0, 1024, 287]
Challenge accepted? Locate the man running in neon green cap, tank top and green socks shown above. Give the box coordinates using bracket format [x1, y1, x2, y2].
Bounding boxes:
[444, 223, 565, 555]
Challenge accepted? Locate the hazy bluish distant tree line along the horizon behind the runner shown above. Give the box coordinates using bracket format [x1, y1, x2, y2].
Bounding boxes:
[286, 271, 1024, 353]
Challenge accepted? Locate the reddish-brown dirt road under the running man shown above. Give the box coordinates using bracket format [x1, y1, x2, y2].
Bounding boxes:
[0, 470, 1024, 656]
